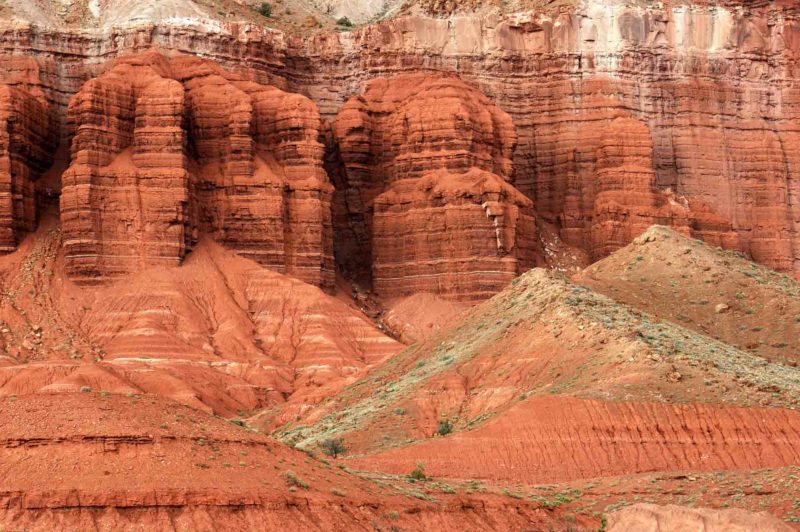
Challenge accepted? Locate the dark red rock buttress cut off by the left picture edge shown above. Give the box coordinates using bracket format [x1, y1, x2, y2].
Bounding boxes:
[0, 85, 55, 252]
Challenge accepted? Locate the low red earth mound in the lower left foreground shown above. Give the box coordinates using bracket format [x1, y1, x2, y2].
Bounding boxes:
[0, 393, 580, 531]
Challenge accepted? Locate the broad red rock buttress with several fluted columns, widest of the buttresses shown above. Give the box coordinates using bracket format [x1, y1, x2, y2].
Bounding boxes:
[61, 54, 333, 288]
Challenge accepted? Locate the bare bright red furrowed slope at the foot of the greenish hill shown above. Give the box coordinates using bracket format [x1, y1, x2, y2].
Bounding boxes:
[349, 396, 800, 484]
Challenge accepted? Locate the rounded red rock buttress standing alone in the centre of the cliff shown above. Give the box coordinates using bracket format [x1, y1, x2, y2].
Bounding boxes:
[333, 75, 536, 300]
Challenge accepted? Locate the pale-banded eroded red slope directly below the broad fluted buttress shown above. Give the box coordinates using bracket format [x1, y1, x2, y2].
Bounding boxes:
[0, 214, 402, 417]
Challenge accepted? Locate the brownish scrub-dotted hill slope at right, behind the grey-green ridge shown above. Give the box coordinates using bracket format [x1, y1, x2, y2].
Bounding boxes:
[576, 227, 800, 365]
